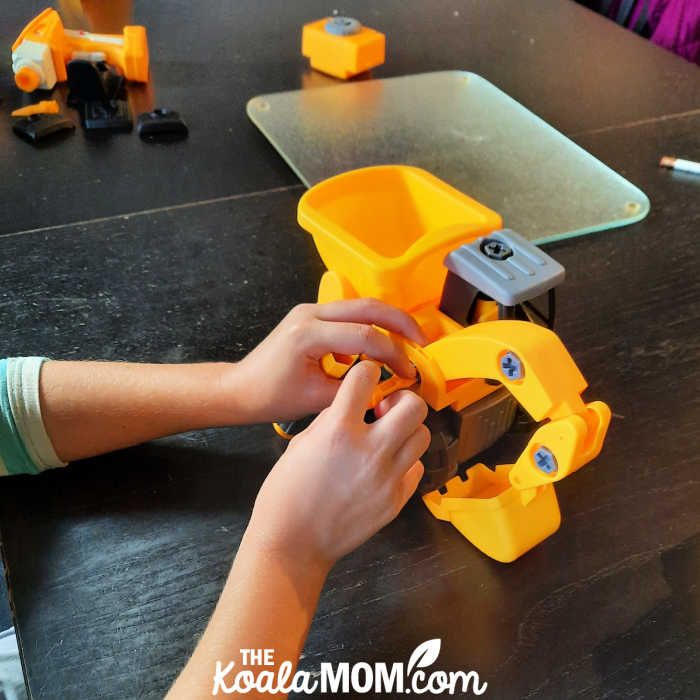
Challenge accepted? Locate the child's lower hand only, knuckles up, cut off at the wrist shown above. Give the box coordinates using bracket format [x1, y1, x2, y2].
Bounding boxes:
[247, 362, 430, 568]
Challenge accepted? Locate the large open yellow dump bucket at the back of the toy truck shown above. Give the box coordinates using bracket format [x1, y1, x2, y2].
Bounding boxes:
[298, 165, 501, 311]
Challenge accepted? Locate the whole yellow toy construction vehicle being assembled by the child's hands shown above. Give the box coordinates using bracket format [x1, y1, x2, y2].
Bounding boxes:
[276, 166, 610, 562]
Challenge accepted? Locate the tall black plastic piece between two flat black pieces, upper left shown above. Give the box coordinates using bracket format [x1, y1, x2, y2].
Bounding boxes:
[67, 59, 133, 131]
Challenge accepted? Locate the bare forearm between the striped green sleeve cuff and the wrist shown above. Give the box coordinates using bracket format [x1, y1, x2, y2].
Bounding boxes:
[39, 361, 252, 462]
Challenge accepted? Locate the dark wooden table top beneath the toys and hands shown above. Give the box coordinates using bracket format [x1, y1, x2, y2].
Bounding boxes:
[0, 0, 700, 699]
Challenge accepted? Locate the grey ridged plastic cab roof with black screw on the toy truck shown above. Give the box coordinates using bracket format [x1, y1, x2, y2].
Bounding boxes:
[445, 229, 565, 306]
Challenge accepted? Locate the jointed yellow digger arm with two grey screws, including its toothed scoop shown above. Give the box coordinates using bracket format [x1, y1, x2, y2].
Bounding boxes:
[419, 321, 610, 562]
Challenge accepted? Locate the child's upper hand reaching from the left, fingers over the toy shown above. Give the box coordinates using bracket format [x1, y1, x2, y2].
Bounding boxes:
[230, 299, 426, 422]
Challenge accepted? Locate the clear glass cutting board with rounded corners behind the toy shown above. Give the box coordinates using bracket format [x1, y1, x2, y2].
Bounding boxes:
[247, 71, 649, 243]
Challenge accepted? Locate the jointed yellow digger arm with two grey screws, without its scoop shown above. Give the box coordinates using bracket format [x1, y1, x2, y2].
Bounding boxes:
[423, 321, 610, 492]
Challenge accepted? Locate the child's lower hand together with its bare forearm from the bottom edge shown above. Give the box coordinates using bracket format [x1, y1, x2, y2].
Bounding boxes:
[168, 362, 430, 700]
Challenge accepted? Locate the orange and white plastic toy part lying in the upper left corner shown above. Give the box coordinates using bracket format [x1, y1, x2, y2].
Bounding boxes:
[12, 8, 148, 92]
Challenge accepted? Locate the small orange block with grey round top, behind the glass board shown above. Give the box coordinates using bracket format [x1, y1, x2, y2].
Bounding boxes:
[301, 17, 386, 80]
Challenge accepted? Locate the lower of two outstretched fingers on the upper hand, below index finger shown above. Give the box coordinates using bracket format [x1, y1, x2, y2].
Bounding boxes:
[303, 321, 416, 378]
